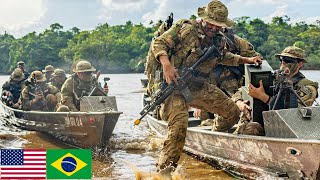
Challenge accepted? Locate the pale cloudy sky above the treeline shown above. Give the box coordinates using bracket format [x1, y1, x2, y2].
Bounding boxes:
[0, 0, 320, 37]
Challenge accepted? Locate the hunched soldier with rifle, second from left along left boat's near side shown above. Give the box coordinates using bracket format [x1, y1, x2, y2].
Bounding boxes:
[20, 71, 61, 111]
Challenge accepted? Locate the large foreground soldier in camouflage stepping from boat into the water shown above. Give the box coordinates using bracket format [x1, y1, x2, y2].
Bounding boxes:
[152, 0, 262, 173]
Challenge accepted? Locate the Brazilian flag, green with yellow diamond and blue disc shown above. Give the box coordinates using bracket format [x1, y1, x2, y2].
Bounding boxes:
[47, 149, 92, 179]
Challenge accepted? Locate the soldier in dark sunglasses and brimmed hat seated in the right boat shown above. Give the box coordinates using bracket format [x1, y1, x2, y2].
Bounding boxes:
[232, 46, 319, 135]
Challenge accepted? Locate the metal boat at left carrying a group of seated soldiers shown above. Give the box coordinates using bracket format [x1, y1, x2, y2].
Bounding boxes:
[0, 96, 122, 148]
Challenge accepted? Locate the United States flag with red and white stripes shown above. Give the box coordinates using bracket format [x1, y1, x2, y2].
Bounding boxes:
[0, 149, 46, 179]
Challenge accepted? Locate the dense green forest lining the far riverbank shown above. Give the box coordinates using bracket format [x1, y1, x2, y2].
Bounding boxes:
[0, 15, 320, 73]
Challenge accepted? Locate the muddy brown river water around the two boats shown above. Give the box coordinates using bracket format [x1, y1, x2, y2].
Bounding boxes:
[0, 71, 320, 180]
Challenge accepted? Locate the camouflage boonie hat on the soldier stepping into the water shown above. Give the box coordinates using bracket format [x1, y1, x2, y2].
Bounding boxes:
[198, 0, 234, 27]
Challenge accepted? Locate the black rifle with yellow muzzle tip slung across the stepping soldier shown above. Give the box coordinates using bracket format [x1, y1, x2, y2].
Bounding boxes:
[134, 45, 222, 125]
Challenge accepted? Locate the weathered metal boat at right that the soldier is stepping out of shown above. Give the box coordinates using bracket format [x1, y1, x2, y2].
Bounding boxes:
[145, 94, 320, 179]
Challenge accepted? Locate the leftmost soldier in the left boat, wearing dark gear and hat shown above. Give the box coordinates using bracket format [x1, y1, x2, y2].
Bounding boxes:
[2, 68, 24, 109]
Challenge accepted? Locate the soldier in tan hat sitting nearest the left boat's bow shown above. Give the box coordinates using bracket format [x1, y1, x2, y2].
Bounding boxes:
[57, 60, 108, 112]
